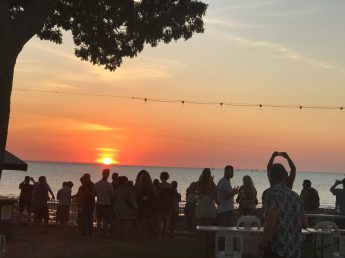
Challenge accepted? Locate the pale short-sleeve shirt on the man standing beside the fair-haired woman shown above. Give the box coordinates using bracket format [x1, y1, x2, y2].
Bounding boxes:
[217, 177, 234, 213]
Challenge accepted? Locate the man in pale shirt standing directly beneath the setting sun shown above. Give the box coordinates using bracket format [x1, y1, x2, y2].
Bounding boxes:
[94, 169, 114, 234]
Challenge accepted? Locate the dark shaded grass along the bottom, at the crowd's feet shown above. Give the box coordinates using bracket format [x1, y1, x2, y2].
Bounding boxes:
[5, 225, 312, 258]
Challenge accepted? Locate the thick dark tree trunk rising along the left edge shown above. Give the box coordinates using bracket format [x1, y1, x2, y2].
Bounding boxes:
[0, 0, 59, 179]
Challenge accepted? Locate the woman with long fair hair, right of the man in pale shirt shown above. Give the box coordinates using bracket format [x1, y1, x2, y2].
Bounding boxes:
[236, 175, 258, 216]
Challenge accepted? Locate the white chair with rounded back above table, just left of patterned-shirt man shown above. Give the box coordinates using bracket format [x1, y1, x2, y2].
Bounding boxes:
[236, 215, 261, 254]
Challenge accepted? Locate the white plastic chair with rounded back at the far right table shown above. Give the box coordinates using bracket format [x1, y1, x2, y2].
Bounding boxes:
[314, 220, 341, 258]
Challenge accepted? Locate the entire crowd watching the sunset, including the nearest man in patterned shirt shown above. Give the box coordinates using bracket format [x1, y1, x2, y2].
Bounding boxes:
[19, 152, 345, 258]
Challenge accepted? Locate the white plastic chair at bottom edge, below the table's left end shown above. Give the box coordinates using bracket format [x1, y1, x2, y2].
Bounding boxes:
[215, 231, 243, 258]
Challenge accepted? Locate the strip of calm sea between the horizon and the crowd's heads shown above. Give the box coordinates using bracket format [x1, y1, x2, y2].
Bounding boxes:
[0, 161, 345, 208]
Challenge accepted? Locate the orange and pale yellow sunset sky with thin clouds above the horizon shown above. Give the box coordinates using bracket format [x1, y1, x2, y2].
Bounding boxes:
[7, 0, 345, 172]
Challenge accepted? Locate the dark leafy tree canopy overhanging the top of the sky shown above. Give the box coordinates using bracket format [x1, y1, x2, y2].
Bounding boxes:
[9, 0, 207, 70]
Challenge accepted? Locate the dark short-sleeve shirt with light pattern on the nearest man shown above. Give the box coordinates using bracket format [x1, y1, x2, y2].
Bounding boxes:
[264, 185, 304, 258]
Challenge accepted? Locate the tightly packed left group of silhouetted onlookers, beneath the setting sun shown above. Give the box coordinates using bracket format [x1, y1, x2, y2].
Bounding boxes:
[18, 169, 181, 240]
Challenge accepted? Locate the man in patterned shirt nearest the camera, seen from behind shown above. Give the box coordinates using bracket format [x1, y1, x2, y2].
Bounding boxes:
[257, 164, 306, 258]
